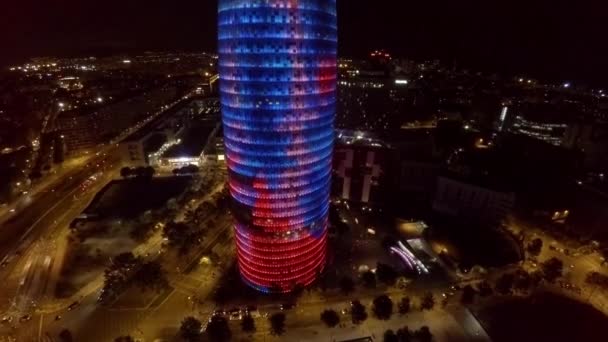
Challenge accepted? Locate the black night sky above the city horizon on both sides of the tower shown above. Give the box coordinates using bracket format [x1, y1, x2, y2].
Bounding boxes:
[0, 0, 608, 85]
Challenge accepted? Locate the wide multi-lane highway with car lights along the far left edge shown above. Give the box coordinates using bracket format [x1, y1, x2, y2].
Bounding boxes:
[0, 150, 120, 336]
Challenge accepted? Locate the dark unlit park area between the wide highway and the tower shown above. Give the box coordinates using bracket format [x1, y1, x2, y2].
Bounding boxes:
[56, 177, 192, 298]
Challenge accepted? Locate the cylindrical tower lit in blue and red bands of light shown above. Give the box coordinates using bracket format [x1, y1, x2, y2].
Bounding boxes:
[219, 0, 337, 292]
